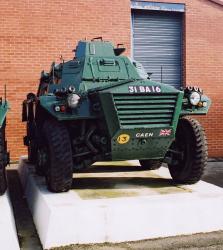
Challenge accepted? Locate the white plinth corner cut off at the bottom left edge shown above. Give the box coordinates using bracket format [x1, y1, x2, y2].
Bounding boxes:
[0, 192, 20, 250]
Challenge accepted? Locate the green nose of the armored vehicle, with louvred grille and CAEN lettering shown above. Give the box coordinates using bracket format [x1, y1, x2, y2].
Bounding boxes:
[100, 84, 183, 160]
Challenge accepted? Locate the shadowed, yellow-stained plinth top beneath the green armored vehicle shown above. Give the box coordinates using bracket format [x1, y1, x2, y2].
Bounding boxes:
[72, 162, 188, 199]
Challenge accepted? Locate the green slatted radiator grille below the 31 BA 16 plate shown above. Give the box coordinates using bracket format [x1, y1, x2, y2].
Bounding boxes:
[113, 93, 177, 128]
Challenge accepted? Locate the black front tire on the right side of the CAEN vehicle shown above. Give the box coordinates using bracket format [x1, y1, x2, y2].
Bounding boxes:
[168, 117, 208, 184]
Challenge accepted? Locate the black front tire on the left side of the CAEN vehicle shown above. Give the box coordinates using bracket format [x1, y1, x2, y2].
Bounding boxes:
[43, 120, 73, 193]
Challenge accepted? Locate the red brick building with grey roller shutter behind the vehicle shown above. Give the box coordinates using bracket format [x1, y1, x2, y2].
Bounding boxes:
[0, 0, 223, 160]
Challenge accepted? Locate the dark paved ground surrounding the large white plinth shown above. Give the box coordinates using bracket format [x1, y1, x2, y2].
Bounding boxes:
[8, 160, 223, 250]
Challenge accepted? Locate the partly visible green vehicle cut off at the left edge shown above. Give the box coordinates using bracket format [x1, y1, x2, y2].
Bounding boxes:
[0, 94, 9, 195]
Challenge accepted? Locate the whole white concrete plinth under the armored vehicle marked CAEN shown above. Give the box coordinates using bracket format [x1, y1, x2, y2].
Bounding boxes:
[19, 159, 223, 249]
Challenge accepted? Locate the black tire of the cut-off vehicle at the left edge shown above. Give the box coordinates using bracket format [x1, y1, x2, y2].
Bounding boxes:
[0, 125, 7, 195]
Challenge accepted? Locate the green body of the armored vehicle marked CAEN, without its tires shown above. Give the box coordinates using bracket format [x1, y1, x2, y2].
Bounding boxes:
[24, 41, 211, 168]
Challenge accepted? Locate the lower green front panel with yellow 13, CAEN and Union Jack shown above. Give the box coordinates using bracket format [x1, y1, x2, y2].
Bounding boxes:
[111, 127, 174, 160]
